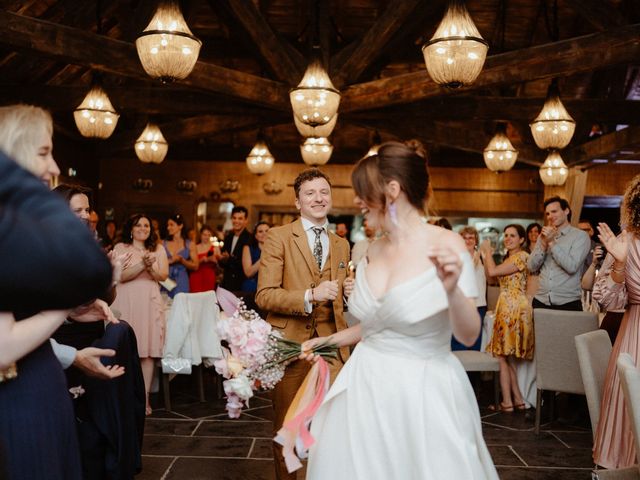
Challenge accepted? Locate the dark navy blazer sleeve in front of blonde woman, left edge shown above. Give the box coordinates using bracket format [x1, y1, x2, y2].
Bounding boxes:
[0, 152, 111, 313]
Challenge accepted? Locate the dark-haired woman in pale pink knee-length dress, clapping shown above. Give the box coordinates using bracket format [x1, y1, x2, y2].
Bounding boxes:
[113, 214, 169, 415]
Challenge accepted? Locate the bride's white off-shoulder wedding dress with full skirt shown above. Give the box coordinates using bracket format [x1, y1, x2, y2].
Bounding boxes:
[307, 253, 498, 480]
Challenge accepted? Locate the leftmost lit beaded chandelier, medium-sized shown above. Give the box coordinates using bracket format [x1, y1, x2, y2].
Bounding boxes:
[73, 84, 120, 138]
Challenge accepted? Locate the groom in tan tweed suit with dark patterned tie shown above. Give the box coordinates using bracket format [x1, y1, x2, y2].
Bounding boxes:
[256, 168, 349, 480]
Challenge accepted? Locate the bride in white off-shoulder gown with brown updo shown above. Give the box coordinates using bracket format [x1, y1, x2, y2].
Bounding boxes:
[301, 142, 498, 480]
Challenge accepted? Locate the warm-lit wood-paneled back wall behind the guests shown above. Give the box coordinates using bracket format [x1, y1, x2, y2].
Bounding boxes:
[96, 158, 640, 227]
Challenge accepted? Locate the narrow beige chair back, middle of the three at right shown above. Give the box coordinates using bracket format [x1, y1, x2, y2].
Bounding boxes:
[575, 330, 612, 438]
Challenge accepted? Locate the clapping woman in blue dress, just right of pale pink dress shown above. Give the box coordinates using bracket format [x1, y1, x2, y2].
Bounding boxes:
[162, 213, 199, 298]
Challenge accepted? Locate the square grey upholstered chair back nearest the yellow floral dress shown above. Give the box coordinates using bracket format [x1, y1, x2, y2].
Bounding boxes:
[533, 308, 598, 395]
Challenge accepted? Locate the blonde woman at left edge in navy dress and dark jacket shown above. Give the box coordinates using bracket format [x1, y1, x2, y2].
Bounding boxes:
[0, 105, 111, 480]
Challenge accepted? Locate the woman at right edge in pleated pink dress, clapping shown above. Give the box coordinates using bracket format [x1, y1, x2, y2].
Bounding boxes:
[593, 175, 640, 468]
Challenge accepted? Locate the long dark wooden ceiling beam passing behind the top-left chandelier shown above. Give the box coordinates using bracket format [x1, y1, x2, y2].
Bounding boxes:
[0, 10, 290, 111]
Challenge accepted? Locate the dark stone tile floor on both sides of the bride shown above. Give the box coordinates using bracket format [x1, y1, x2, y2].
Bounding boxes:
[136, 372, 593, 480]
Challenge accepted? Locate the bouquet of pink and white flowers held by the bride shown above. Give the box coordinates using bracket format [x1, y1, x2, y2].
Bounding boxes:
[214, 288, 337, 418]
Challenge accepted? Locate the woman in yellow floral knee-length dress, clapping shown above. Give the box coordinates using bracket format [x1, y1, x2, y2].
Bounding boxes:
[480, 224, 534, 412]
